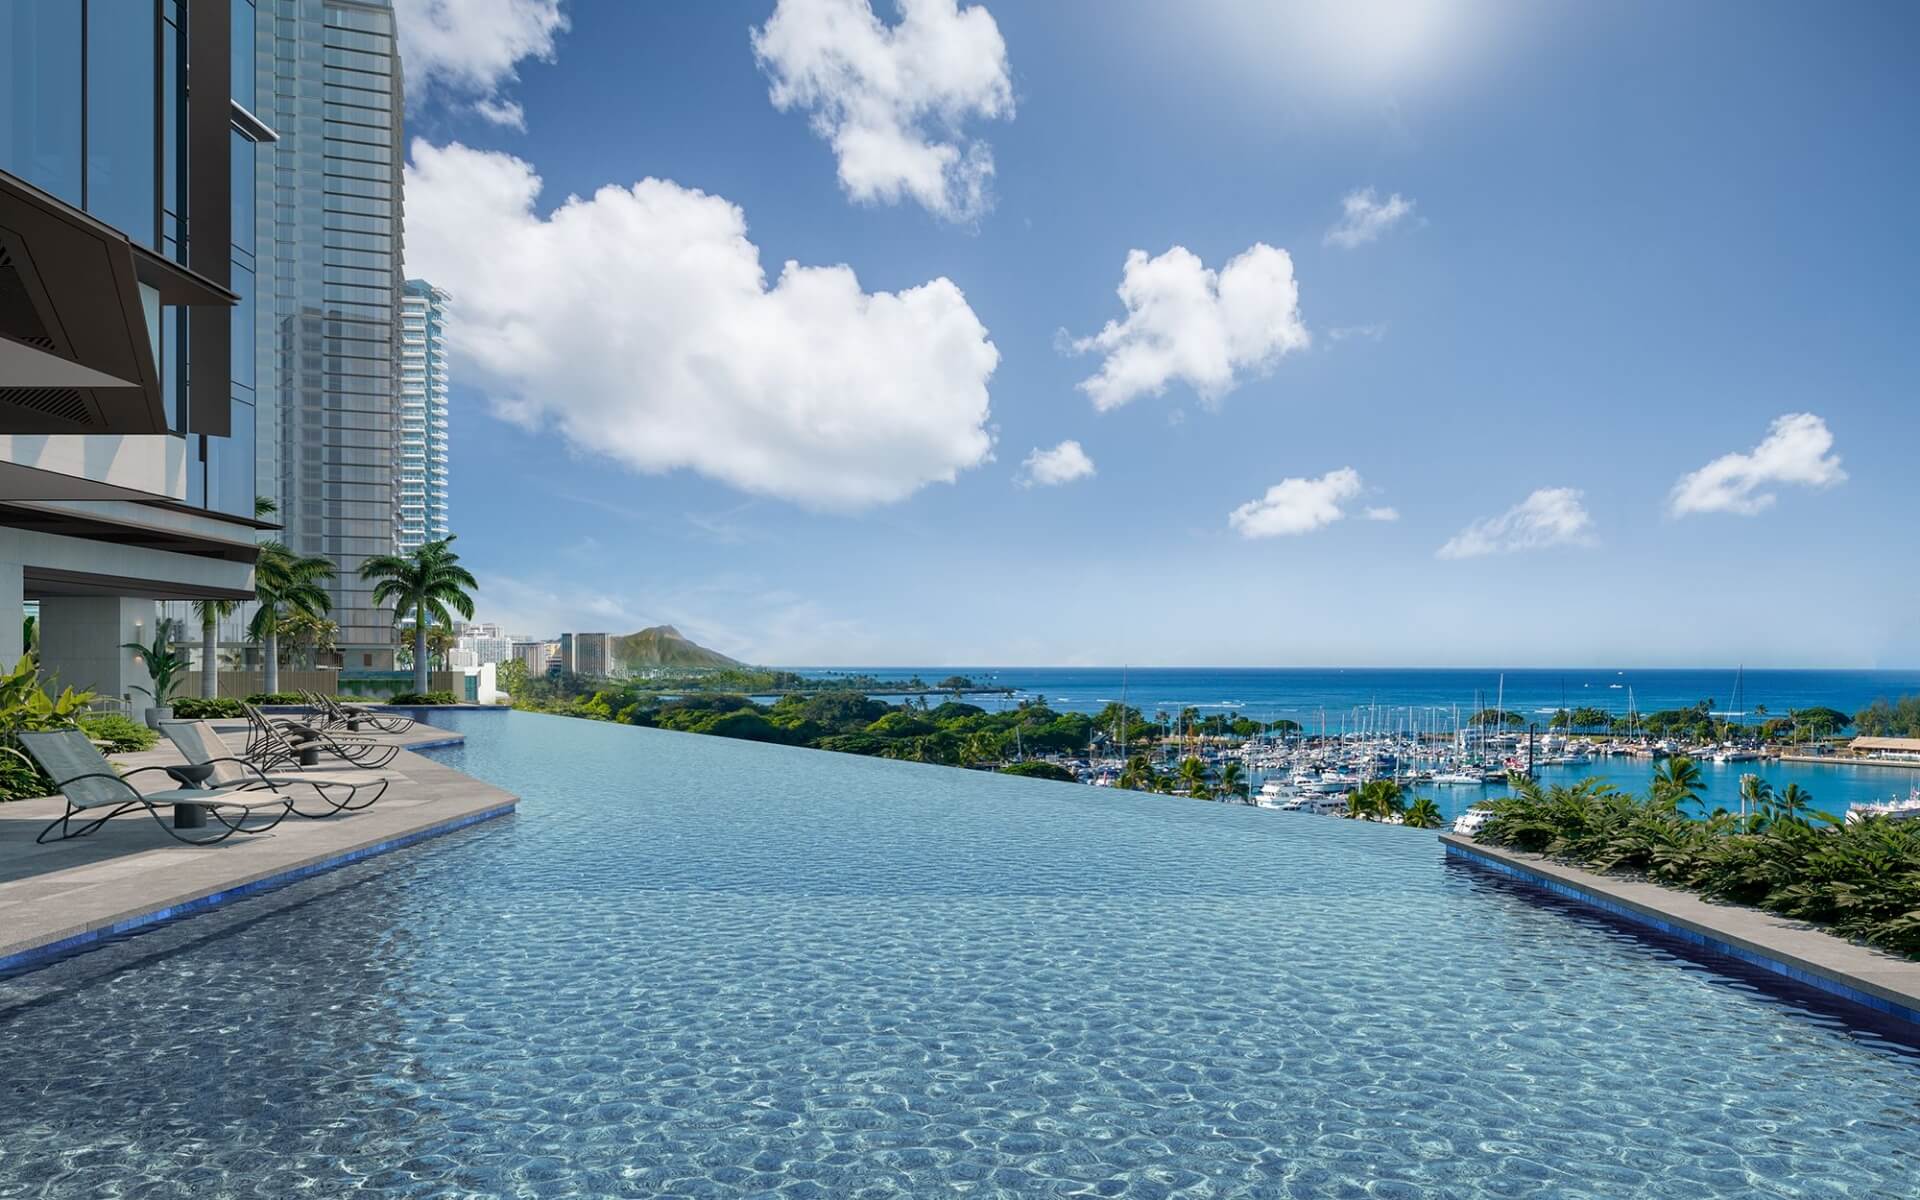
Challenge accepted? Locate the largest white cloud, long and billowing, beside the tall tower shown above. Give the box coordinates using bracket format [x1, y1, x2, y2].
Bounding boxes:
[407, 142, 1000, 511]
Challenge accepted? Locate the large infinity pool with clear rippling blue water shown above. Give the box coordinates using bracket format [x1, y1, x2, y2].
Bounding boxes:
[0, 712, 1920, 1200]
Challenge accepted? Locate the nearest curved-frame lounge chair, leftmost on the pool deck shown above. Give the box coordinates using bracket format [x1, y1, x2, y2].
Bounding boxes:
[19, 730, 294, 847]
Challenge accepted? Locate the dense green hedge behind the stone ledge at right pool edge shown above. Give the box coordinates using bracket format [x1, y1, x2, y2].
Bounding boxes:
[1475, 771, 1920, 958]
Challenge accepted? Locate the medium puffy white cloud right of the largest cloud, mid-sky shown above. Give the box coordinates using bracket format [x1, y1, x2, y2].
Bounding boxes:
[1068, 242, 1311, 411]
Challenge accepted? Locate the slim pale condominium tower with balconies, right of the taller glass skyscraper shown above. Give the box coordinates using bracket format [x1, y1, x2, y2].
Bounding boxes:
[394, 278, 447, 551]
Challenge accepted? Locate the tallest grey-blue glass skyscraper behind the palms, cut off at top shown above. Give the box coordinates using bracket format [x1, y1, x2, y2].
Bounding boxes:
[255, 0, 401, 670]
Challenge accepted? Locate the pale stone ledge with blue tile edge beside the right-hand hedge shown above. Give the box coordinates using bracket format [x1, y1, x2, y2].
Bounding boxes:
[1440, 833, 1920, 1029]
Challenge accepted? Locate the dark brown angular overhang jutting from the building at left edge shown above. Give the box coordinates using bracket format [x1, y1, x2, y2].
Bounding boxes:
[0, 171, 238, 434]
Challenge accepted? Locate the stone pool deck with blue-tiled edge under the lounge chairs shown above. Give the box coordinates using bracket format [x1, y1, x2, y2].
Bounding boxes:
[0, 722, 518, 972]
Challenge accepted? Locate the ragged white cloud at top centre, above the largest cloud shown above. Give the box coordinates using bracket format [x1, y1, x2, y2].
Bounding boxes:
[753, 0, 1014, 221]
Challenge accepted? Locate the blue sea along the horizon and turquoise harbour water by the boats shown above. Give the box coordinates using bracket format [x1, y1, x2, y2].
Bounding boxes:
[799, 666, 1920, 814]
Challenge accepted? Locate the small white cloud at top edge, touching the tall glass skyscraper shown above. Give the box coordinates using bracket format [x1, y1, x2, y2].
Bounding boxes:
[394, 0, 566, 131]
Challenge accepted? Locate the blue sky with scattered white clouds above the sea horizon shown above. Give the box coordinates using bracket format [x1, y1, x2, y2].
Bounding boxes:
[399, 0, 1920, 666]
